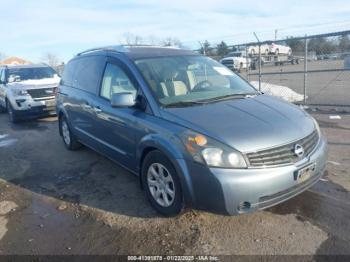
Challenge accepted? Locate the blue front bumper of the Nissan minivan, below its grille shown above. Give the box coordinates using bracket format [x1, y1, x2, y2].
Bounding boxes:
[189, 137, 327, 215]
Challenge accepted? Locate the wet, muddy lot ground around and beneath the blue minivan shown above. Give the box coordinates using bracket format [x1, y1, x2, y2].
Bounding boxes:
[0, 111, 350, 255]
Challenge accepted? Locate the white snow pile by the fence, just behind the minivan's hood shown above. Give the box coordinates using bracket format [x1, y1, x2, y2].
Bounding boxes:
[250, 81, 304, 102]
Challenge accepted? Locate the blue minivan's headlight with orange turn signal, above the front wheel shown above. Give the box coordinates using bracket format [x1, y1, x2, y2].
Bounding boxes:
[181, 131, 247, 168]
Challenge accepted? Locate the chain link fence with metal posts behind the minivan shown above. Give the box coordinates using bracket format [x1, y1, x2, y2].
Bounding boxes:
[215, 31, 350, 107]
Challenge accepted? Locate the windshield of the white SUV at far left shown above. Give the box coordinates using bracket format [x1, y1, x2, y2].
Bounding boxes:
[7, 67, 57, 83]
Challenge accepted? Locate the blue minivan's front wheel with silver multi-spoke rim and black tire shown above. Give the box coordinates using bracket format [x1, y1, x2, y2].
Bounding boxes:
[141, 150, 184, 217]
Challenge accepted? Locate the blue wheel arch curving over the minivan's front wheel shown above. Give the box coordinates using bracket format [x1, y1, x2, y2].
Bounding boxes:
[136, 134, 195, 205]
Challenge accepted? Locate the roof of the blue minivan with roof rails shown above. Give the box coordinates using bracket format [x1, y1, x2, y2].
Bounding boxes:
[77, 45, 198, 60]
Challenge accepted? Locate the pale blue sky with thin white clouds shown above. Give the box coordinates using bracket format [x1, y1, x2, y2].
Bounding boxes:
[0, 0, 350, 62]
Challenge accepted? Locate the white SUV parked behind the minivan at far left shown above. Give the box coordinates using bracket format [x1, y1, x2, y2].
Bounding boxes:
[0, 64, 60, 122]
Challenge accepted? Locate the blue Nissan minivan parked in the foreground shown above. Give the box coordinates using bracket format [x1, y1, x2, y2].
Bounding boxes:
[57, 46, 326, 216]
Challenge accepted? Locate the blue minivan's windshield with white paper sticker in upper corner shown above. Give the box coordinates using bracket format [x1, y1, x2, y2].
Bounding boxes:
[135, 55, 258, 107]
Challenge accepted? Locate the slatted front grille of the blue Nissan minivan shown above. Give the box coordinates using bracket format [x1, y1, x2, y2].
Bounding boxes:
[247, 130, 319, 167]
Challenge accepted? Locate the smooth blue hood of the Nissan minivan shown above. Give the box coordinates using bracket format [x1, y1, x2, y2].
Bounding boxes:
[161, 95, 315, 153]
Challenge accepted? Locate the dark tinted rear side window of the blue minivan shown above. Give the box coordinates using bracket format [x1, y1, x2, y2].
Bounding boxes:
[73, 56, 106, 94]
